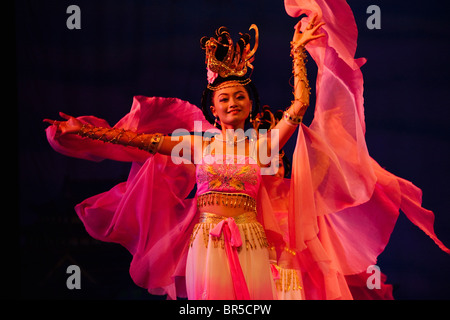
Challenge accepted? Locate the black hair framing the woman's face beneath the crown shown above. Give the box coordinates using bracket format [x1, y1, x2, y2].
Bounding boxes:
[201, 76, 260, 130]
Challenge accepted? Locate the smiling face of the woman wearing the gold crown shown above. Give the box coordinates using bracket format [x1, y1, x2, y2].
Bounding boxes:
[211, 86, 252, 129]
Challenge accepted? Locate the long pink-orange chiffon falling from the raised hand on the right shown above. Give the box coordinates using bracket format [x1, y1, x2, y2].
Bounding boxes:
[285, 0, 450, 299]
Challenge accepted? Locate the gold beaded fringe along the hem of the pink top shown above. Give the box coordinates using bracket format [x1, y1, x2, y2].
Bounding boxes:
[197, 192, 256, 212]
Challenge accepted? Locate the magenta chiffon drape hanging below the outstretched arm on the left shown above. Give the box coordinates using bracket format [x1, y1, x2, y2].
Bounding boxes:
[75, 155, 197, 299]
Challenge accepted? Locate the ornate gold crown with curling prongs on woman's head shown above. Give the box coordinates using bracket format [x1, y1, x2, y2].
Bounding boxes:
[200, 24, 259, 85]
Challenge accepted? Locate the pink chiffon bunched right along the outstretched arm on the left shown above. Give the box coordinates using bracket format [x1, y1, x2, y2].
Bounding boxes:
[46, 96, 214, 163]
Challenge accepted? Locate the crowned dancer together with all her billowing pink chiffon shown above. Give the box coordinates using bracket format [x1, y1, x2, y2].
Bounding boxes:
[46, 0, 449, 299]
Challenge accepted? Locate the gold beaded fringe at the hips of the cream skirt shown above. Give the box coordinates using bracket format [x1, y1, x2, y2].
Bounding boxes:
[189, 222, 269, 250]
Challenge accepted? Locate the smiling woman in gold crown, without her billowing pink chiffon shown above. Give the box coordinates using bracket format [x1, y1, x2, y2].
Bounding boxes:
[44, 19, 324, 299]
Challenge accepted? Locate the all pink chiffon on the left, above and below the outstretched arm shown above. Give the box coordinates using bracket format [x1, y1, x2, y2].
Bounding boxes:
[47, 96, 219, 299]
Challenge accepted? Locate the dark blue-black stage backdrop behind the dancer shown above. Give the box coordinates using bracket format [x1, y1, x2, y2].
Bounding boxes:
[15, 0, 450, 299]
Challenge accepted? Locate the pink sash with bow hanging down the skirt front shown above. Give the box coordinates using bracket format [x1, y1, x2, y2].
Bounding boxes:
[209, 218, 250, 300]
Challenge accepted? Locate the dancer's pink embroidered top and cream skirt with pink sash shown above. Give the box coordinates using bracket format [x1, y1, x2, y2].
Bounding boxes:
[186, 138, 276, 300]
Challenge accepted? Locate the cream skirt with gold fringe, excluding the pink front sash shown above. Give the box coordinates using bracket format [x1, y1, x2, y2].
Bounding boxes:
[186, 212, 277, 300]
